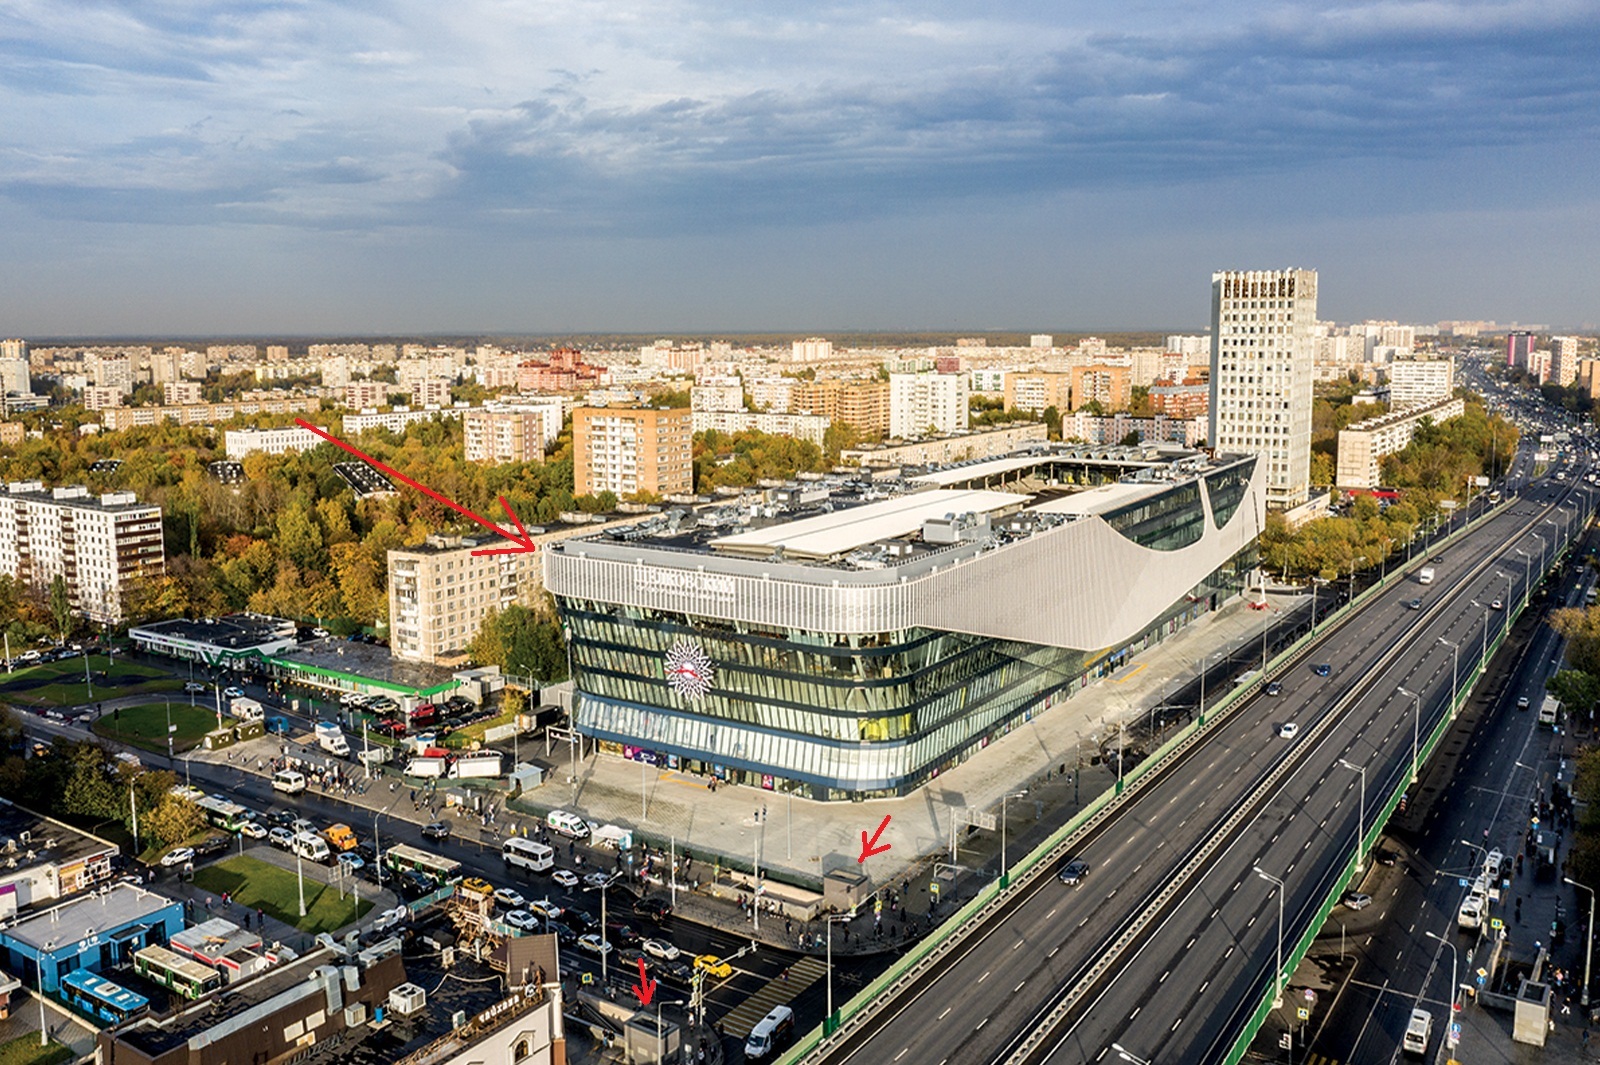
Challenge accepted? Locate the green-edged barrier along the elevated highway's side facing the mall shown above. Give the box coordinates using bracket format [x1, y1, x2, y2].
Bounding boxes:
[778, 501, 1510, 1065]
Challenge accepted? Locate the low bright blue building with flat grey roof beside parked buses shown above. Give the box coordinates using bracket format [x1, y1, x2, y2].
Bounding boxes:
[0, 884, 184, 998]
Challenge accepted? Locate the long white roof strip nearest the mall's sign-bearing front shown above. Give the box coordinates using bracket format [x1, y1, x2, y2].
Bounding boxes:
[710, 488, 1029, 558]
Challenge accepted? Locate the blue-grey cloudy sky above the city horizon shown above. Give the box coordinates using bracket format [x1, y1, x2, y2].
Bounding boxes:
[0, 0, 1600, 336]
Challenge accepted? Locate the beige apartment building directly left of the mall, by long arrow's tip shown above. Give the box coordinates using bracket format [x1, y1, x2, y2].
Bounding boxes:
[389, 536, 539, 665]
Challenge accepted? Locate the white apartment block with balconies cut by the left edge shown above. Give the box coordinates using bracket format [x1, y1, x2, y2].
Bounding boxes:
[0, 481, 166, 624]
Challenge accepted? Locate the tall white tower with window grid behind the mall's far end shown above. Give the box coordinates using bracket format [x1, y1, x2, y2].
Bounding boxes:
[1211, 269, 1317, 509]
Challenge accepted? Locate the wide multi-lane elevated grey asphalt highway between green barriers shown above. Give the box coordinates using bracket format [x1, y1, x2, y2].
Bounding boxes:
[813, 454, 1589, 1065]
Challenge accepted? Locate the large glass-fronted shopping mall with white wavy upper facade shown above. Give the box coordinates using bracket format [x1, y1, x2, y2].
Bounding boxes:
[544, 446, 1266, 800]
